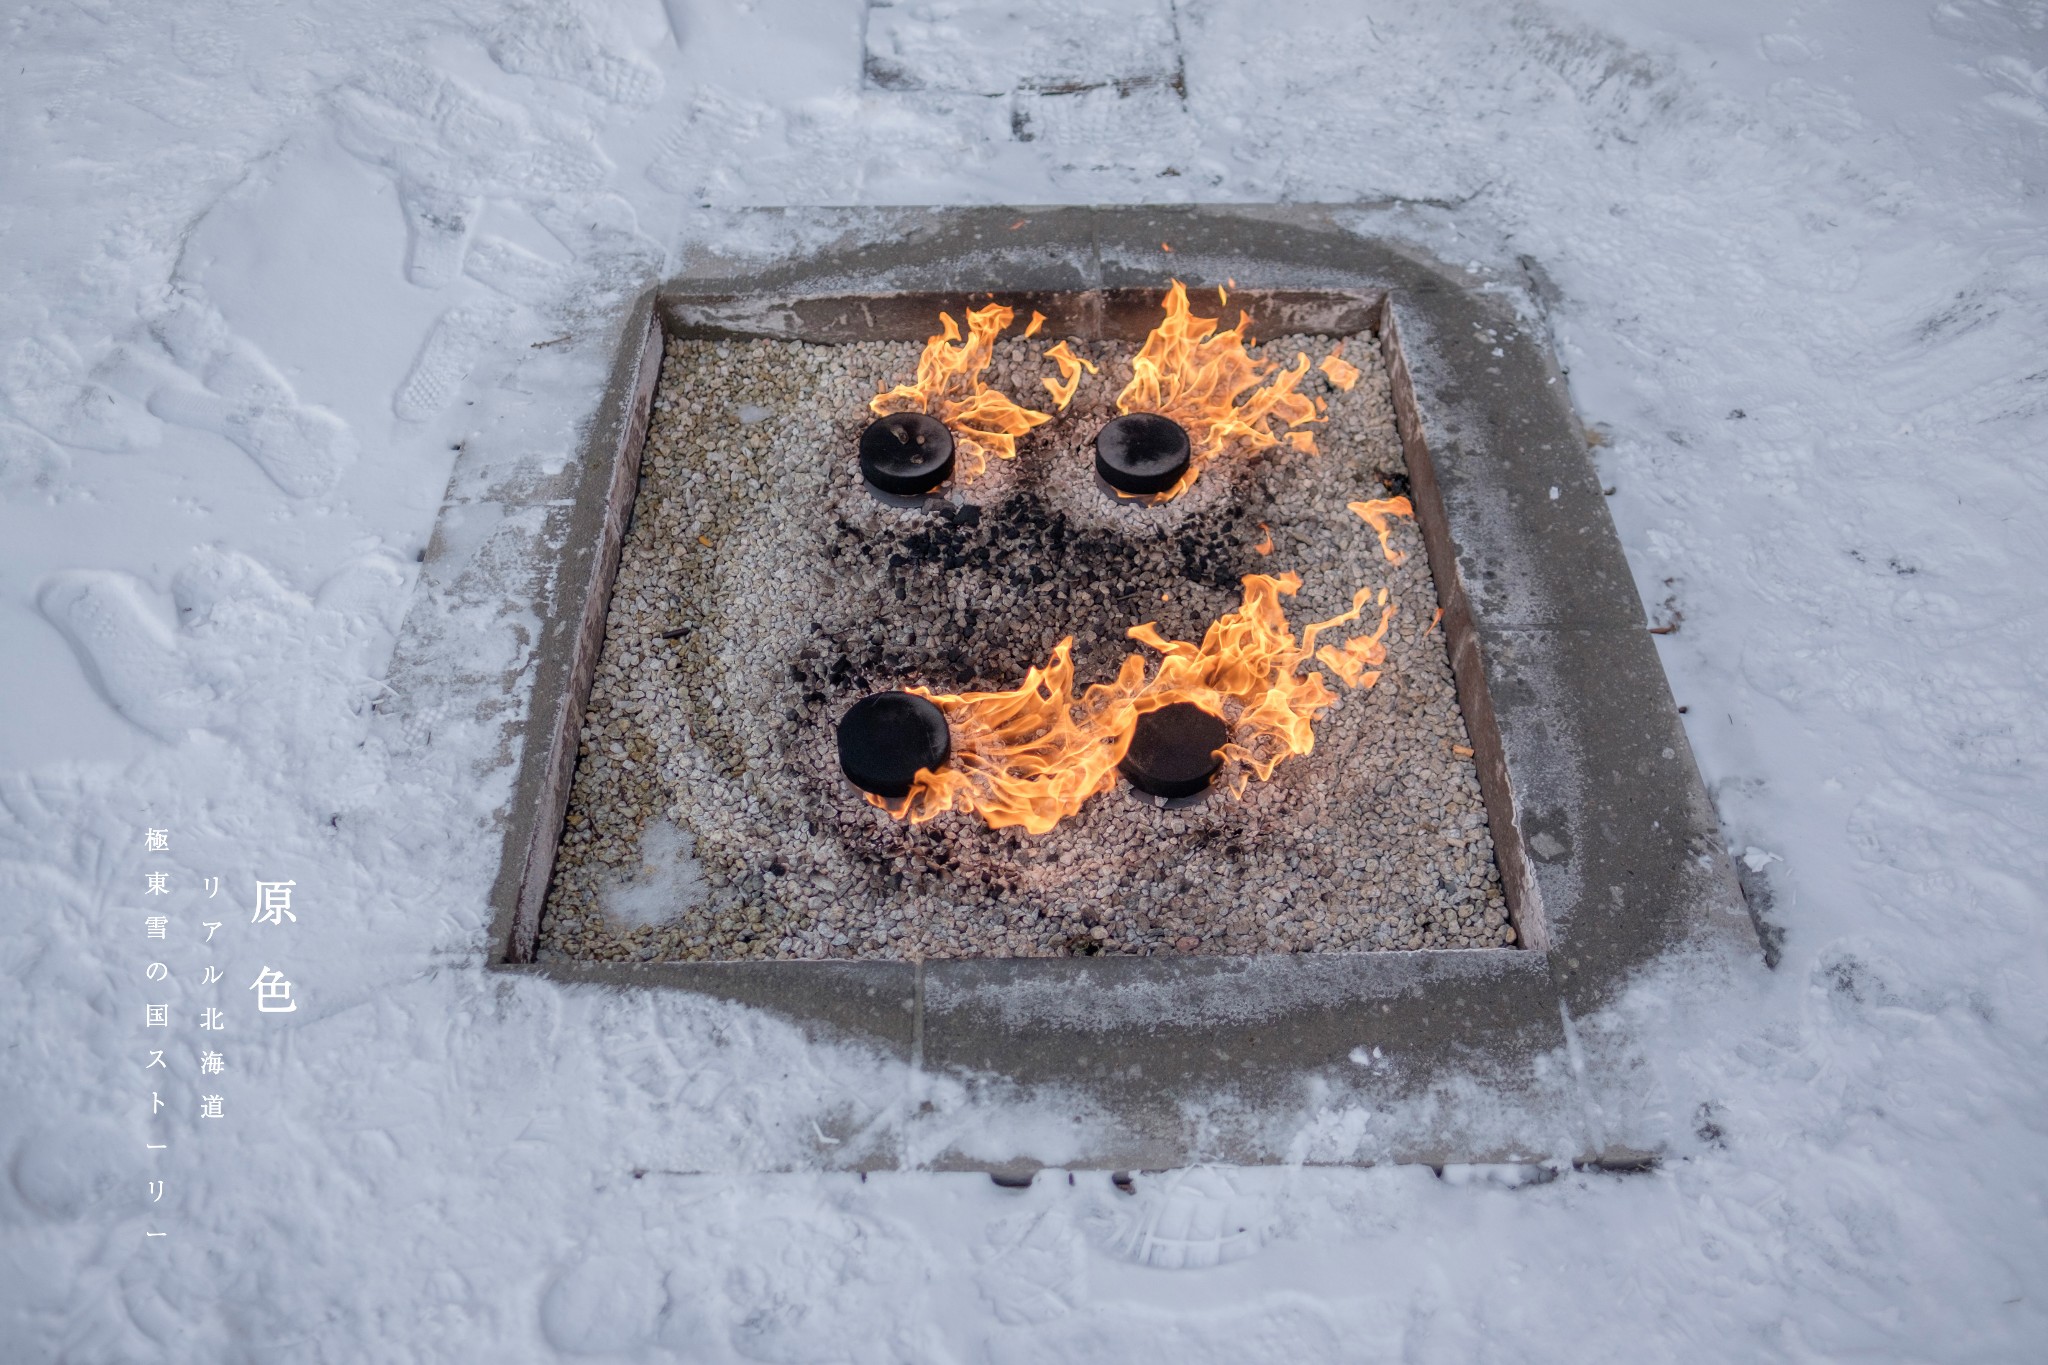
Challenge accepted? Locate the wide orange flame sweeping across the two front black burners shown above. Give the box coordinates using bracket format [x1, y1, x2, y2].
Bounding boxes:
[866, 573, 1395, 835]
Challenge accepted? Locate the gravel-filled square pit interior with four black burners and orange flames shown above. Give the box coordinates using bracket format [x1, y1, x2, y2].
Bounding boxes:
[539, 287, 1516, 962]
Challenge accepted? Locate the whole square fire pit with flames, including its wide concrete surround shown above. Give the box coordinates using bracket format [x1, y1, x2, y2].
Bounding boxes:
[468, 207, 1755, 1175]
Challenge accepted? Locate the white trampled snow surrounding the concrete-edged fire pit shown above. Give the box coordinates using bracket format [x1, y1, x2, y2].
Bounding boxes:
[0, 0, 2048, 1363]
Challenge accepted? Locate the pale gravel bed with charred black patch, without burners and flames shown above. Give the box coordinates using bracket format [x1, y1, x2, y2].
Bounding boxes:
[541, 338, 1513, 960]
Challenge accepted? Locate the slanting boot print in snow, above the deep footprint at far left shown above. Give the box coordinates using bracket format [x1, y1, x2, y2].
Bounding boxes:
[150, 295, 356, 497]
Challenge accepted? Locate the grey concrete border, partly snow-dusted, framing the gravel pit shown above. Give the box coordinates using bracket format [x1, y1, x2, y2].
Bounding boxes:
[456, 207, 1757, 1171]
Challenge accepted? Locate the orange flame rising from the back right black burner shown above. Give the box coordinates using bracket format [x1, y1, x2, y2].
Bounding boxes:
[1116, 280, 1323, 497]
